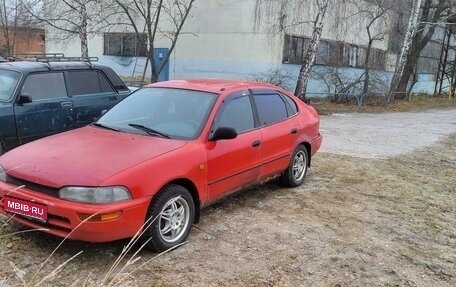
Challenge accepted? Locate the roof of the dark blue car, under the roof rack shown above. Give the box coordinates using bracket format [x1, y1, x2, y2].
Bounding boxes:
[0, 61, 111, 74]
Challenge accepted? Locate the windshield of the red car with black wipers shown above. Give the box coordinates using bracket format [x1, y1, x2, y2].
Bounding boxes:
[95, 88, 216, 139]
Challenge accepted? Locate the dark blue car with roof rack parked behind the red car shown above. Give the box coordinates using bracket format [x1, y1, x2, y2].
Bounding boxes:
[0, 62, 130, 154]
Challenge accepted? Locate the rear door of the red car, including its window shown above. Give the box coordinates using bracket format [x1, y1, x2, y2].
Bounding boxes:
[252, 89, 299, 178]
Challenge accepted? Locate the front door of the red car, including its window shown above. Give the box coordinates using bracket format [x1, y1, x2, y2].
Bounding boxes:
[207, 91, 262, 202]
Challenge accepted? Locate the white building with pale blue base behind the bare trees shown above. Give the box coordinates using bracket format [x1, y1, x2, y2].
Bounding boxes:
[46, 0, 435, 93]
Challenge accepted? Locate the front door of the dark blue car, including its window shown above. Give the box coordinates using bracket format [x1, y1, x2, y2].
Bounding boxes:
[14, 72, 72, 144]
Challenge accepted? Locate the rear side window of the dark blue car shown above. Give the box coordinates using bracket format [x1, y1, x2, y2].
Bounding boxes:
[68, 71, 114, 96]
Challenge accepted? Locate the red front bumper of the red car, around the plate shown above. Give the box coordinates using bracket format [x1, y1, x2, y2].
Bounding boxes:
[0, 182, 150, 242]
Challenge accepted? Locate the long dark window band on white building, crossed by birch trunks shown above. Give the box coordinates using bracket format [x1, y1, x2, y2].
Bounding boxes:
[282, 35, 386, 70]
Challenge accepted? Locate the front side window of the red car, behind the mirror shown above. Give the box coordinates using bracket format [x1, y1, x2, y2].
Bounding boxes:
[216, 93, 255, 134]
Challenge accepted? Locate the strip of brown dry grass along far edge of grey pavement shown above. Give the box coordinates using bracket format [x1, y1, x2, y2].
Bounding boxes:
[310, 95, 456, 115]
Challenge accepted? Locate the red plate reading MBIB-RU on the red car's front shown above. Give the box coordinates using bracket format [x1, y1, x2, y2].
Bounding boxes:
[3, 195, 48, 222]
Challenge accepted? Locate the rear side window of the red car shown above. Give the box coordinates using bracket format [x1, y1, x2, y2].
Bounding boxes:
[253, 93, 288, 126]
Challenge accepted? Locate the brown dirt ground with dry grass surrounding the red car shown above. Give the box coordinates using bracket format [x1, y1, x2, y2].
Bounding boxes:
[0, 110, 456, 286]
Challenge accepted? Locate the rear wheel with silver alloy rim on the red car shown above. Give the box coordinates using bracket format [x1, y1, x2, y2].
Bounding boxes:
[279, 145, 309, 187]
